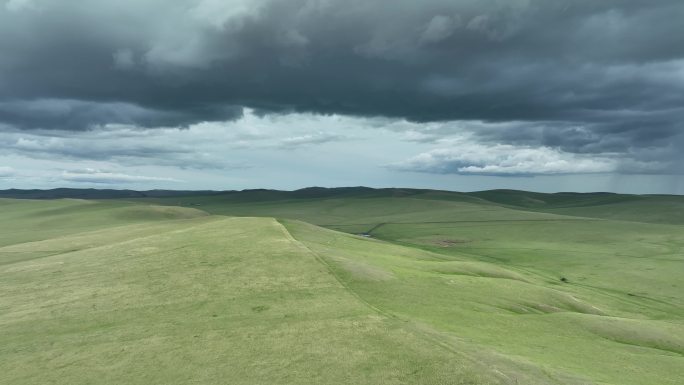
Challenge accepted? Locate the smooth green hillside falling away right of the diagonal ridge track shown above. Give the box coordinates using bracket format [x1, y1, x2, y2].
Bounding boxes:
[286, 221, 684, 385]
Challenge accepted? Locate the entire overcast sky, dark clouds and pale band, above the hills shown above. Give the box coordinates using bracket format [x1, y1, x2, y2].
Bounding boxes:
[0, 0, 684, 194]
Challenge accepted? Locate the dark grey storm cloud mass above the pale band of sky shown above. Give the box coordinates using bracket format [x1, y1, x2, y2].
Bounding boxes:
[0, 0, 684, 164]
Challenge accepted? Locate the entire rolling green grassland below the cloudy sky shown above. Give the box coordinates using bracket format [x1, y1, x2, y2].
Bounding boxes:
[0, 188, 684, 385]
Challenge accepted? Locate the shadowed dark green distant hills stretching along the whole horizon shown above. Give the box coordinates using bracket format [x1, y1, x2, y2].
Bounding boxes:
[0, 186, 684, 224]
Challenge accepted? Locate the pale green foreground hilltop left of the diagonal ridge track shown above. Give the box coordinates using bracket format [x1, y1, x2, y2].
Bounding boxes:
[0, 202, 505, 384]
